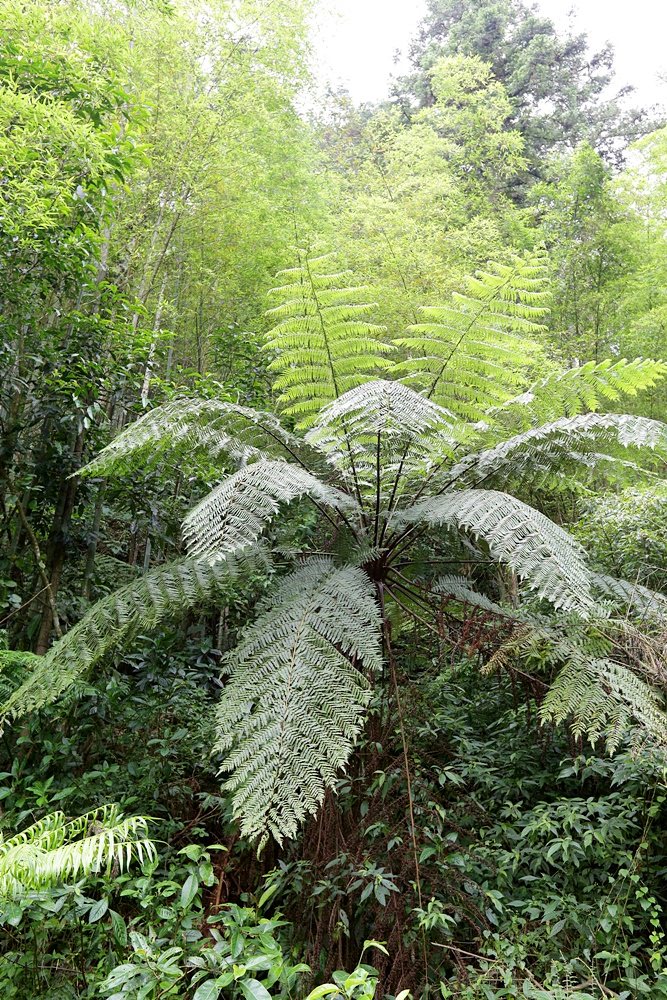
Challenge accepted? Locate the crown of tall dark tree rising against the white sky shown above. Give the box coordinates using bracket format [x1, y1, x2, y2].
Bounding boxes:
[395, 0, 651, 176]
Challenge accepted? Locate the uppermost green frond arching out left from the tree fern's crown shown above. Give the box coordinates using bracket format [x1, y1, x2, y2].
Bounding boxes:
[79, 399, 314, 476]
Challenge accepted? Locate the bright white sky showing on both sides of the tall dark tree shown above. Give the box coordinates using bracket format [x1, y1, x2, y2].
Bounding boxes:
[315, 0, 667, 105]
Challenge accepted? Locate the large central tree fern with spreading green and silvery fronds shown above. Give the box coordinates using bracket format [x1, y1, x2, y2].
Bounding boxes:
[5, 254, 667, 841]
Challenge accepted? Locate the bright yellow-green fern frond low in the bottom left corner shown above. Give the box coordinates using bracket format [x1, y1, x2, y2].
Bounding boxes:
[0, 805, 155, 899]
